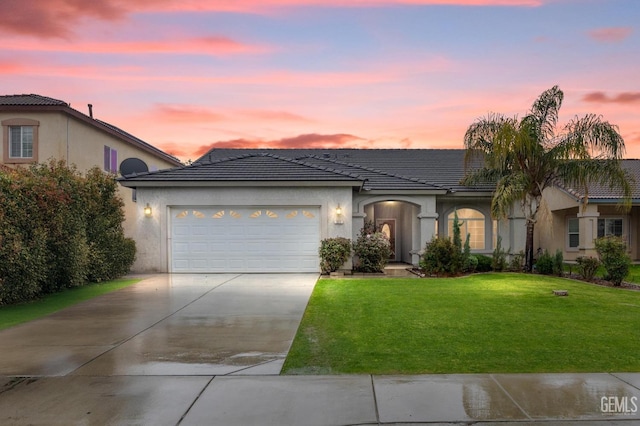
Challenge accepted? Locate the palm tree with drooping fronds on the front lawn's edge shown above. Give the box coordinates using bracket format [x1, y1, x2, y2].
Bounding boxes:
[462, 86, 631, 272]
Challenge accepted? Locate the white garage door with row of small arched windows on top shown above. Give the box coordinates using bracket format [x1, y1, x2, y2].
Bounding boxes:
[171, 207, 320, 272]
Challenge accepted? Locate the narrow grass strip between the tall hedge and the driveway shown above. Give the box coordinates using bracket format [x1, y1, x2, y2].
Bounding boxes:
[0, 279, 140, 330]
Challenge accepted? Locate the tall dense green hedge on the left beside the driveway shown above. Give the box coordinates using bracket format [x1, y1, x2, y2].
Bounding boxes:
[0, 161, 135, 305]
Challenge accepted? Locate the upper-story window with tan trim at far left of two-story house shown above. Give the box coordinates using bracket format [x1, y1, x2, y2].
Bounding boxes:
[2, 118, 40, 163]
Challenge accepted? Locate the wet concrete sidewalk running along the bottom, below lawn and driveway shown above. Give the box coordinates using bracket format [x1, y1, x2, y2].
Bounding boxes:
[0, 373, 640, 426]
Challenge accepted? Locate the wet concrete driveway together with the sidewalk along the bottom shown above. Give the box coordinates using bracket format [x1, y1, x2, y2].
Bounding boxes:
[0, 275, 640, 425]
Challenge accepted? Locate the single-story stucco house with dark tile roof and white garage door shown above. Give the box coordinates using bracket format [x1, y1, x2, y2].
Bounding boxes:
[120, 149, 524, 272]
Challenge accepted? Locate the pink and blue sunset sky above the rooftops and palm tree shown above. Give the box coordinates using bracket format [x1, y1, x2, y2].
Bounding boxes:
[0, 0, 640, 160]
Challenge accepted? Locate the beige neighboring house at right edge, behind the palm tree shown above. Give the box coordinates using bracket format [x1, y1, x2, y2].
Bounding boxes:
[534, 160, 640, 261]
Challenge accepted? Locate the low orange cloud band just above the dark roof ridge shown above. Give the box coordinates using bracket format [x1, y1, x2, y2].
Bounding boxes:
[193, 133, 370, 156]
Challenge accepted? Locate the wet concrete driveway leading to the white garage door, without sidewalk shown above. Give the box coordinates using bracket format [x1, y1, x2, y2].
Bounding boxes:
[0, 274, 318, 376]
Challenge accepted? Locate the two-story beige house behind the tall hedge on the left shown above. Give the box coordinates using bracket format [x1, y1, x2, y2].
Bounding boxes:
[0, 95, 181, 240]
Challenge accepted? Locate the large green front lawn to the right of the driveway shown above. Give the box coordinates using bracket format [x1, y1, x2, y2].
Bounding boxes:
[283, 273, 640, 374]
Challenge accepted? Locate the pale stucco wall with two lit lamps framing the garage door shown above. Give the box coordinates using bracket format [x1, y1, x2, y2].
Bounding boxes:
[132, 187, 353, 273]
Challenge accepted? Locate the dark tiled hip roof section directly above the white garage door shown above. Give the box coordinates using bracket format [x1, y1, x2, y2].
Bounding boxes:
[120, 154, 363, 186]
